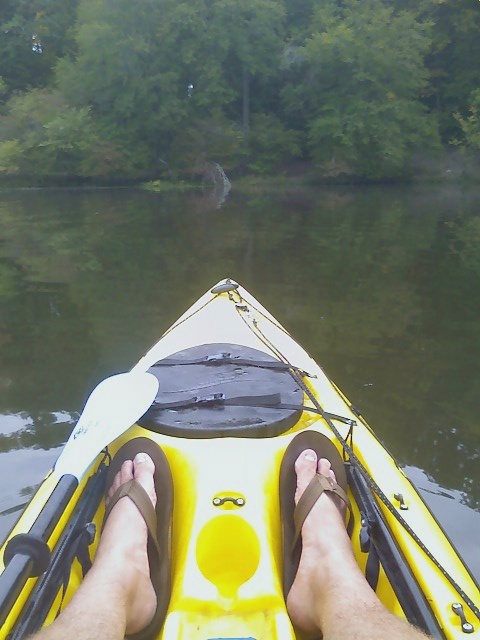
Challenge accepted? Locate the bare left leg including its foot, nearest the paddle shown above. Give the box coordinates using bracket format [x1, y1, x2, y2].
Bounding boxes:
[34, 453, 156, 640]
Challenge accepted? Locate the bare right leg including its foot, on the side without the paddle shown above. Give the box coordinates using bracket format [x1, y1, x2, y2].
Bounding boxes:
[287, 449, 427, 640]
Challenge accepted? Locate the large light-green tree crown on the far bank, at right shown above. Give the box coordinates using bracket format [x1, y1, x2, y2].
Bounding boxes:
[283, 0, 437, 177]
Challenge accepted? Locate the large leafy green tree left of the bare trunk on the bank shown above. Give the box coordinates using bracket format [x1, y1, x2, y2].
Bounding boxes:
[58, 0, 229, 175]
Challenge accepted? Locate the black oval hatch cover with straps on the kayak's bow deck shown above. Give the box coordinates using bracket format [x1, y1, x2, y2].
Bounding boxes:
[138, 343, 303, 438]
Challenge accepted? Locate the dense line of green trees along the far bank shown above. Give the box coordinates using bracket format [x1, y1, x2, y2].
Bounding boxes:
[0, 0, 480, 178]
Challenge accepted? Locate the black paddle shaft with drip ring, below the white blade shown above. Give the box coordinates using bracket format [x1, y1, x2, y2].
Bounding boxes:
[0, 474, 78, 626]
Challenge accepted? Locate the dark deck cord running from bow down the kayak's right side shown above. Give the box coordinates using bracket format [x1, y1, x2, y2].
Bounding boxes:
[228, 288, 480, 633]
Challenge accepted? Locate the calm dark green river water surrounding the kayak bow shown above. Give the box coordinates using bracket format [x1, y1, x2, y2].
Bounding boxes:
[0, 185, 480, 579]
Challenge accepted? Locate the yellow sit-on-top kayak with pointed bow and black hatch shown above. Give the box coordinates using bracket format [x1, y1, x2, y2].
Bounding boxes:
[0, 279, 480, 640]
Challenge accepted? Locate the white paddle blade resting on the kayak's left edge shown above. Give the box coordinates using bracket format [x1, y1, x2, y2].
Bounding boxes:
[55, 372, 158, 480]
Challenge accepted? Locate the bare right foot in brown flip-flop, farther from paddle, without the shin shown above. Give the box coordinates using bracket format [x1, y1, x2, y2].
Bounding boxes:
[287, 449, 358, 635]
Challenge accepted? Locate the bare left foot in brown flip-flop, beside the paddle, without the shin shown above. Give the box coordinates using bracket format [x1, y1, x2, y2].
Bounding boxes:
[92, 453, 157, 634]
